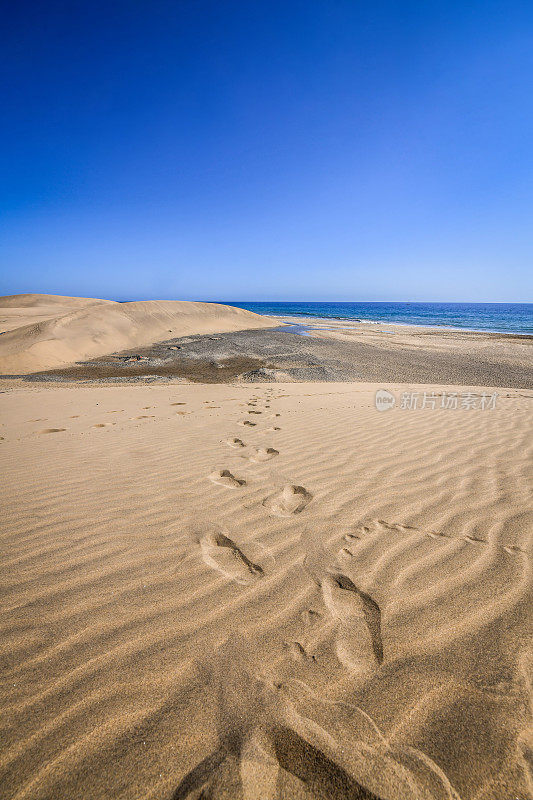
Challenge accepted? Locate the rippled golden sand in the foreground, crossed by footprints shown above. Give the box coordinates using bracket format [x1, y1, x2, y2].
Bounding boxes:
[0, 383, 533, 800]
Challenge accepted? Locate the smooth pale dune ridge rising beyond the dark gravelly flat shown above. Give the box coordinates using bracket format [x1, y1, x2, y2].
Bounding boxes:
[0, 294, 276, 375]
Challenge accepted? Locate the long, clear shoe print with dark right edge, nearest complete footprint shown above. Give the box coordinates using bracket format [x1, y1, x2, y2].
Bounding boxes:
[321, 573, 383, 678]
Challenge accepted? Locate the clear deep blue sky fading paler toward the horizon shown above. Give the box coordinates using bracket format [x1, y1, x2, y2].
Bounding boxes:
[0, 0, 533, 302]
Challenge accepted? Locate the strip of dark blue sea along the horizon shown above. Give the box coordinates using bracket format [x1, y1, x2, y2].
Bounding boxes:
[220, 300, 533, 334]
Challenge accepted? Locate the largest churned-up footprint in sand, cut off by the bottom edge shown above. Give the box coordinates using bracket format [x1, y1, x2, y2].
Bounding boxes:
[169, 648, 459, 800]
